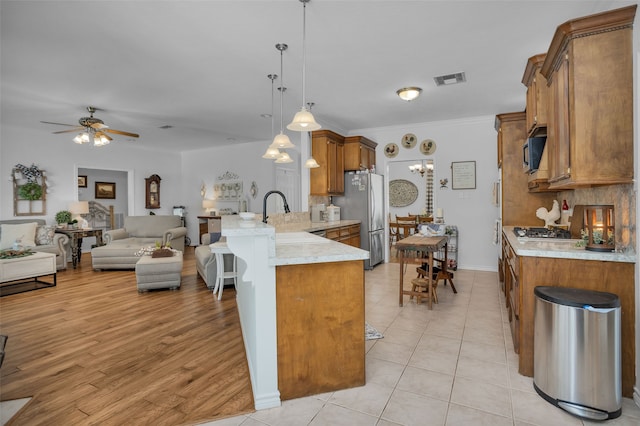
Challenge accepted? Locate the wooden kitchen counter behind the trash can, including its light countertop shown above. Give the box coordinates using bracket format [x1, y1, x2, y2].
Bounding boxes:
[502, 226, 636, 398]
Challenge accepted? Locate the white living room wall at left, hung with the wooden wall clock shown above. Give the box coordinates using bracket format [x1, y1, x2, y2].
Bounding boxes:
[0, 125, 188, 224]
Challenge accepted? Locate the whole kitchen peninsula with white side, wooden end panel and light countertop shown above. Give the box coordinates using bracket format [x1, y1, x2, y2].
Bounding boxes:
[222, 216, 369, 409]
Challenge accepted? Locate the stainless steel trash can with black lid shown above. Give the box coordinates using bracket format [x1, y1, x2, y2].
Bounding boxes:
[533, 286, 622, 420]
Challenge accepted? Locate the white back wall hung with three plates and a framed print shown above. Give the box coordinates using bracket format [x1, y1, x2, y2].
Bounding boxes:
[350, 115, 500, 271]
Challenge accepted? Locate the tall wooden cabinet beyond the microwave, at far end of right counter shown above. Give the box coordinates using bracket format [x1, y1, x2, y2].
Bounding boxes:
[495, 112, 556, 226]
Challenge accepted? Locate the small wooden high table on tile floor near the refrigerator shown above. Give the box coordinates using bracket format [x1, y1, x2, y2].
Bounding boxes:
[396, 234, 449, 309]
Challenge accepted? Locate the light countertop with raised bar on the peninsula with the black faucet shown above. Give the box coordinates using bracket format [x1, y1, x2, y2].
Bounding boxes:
[222, 216, 369, 266]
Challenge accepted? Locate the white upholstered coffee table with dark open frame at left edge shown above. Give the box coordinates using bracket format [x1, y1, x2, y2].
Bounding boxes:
[0, 252, 57, 296]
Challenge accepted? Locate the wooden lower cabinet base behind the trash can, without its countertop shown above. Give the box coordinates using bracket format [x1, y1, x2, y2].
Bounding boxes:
[505, 235, 636, 398]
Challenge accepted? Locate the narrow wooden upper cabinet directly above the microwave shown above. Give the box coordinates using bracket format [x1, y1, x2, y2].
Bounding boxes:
[522, 53, 549, 136]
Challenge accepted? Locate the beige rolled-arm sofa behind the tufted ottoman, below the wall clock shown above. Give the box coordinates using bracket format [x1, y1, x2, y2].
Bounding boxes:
[91, 215, 187, 270]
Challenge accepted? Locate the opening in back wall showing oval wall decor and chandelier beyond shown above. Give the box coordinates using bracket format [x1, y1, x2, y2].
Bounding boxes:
[387, 158, 435, 219]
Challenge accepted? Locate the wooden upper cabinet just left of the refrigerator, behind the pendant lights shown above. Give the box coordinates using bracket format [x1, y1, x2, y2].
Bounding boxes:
[309, 130, 344, 195]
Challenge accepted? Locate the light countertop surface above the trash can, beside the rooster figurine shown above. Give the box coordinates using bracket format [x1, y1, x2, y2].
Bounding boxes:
[502, 226, 636, 263]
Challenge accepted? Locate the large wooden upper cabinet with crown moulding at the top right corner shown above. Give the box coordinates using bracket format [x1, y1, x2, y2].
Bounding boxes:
[541, 5, 637, 190]
